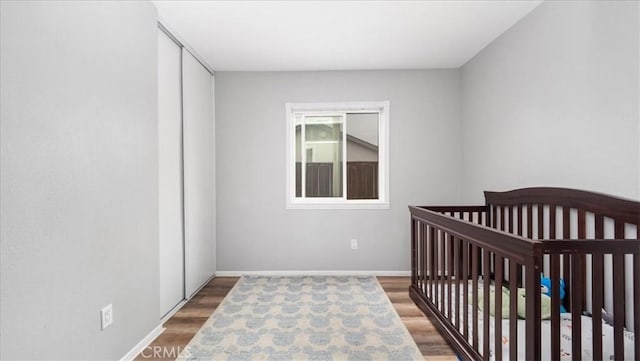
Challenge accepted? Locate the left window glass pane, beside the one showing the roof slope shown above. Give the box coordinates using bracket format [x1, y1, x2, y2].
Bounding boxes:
[305, 116, 344, 198]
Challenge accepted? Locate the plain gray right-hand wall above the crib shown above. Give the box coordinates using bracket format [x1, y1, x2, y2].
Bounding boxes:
[462, 1, 640, 202]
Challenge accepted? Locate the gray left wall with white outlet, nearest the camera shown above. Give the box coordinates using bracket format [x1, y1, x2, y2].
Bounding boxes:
[0, 1, 159, 360]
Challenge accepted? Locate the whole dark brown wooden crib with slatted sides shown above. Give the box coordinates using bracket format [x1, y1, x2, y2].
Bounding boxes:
[409, 188, 640, 360]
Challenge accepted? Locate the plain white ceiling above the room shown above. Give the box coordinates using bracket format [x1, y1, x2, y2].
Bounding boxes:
[153, 0, 542, 71]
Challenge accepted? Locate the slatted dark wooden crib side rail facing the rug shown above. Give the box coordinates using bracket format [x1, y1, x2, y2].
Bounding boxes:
[410, 207, 541, 360]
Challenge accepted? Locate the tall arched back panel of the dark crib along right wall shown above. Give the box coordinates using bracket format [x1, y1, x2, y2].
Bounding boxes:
[484, 187, 640, 348]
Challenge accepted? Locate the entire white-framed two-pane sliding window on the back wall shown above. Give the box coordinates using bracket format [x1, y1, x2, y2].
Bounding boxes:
[286, 101, 389, 208]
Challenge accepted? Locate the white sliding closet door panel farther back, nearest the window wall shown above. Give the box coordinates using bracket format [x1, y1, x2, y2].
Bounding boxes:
[182, 50, 215, 297]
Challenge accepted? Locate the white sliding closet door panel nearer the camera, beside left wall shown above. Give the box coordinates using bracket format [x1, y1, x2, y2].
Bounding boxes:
[158, 31, 184, 315]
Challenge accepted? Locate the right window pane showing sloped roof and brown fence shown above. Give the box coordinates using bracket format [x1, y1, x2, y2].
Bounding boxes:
[347, 113, 379, 199]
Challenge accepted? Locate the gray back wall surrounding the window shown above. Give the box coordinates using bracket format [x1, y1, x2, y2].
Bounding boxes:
[216, 70, 460, 272]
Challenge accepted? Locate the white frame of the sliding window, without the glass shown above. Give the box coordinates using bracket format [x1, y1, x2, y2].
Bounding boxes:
[285, 101, 390, 209]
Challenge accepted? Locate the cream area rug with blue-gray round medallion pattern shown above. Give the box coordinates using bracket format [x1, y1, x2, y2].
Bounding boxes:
[178, 276, 423, 361]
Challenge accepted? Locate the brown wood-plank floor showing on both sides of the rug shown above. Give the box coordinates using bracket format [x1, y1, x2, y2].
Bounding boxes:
[136, 277, 456, 361]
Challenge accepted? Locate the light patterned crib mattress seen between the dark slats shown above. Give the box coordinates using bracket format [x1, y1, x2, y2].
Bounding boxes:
[424, 282, 637, 360]
